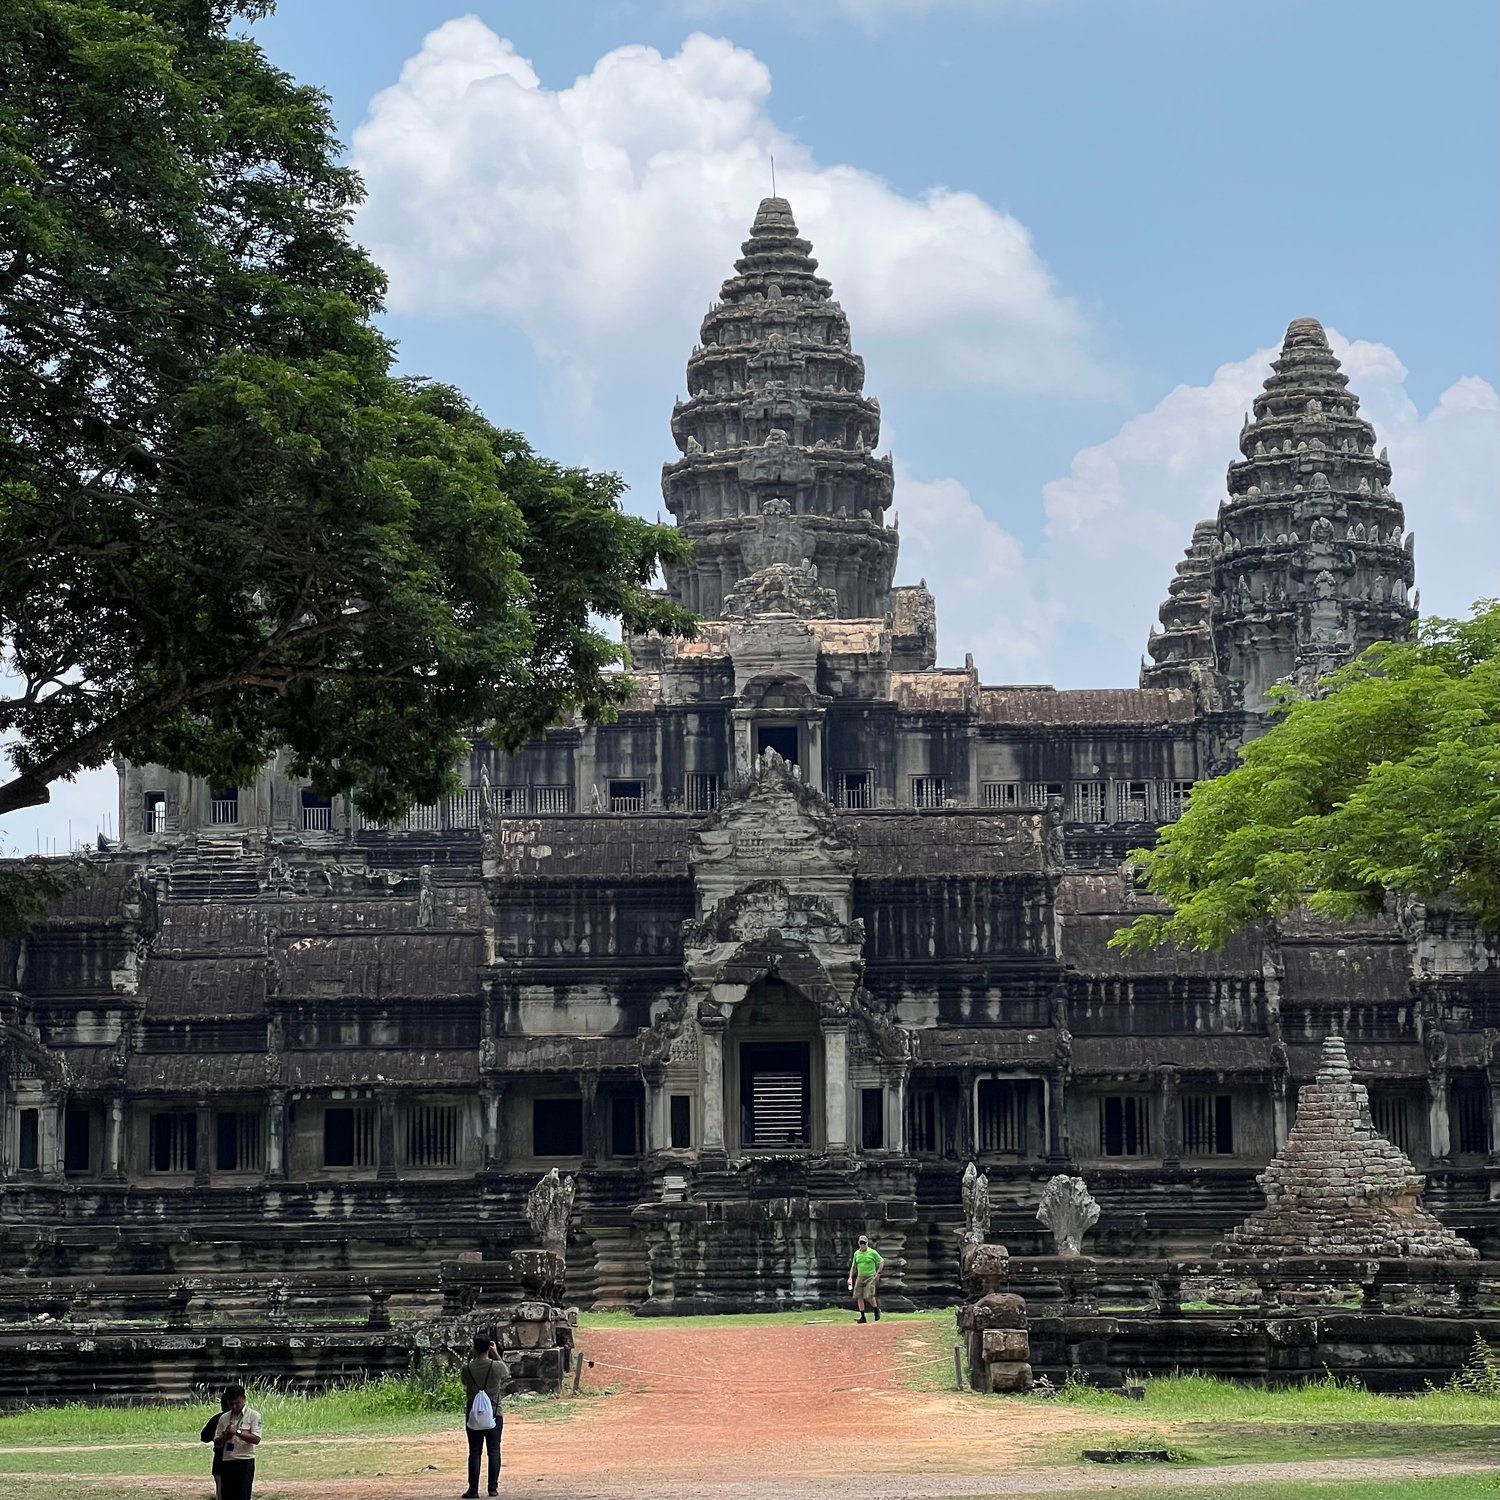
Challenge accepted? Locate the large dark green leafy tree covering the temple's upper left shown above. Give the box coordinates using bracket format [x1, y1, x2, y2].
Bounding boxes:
[0, 0, 692, 818]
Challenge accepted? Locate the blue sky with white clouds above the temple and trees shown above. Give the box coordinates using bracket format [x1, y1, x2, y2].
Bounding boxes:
[6, 0, 1500, 851]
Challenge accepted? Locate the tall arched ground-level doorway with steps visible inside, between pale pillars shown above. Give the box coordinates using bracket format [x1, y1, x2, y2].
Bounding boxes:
[731, 978, 824, 1152]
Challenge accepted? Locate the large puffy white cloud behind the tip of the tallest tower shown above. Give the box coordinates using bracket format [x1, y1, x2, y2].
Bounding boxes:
[354, 17, 1103, 392]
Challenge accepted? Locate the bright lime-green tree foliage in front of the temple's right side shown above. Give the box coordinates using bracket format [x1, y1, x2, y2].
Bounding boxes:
[1112, 602, 1500, 951]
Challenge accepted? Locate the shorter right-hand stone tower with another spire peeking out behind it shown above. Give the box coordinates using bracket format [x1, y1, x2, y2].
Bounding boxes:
[1142, 318, 1416, 737]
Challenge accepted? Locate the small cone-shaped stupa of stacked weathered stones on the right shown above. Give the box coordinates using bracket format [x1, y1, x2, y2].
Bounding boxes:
[1218, 1037, 1479, 1260]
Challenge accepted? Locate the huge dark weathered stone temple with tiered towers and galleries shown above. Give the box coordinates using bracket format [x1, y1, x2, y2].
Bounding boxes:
[0, 198, 1500, 1308]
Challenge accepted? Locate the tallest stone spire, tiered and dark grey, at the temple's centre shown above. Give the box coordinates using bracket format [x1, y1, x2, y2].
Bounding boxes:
[662, 198, 897, 620]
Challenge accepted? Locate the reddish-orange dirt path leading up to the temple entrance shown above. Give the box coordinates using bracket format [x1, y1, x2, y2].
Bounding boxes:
[0, 1317, 1494, 1500]
